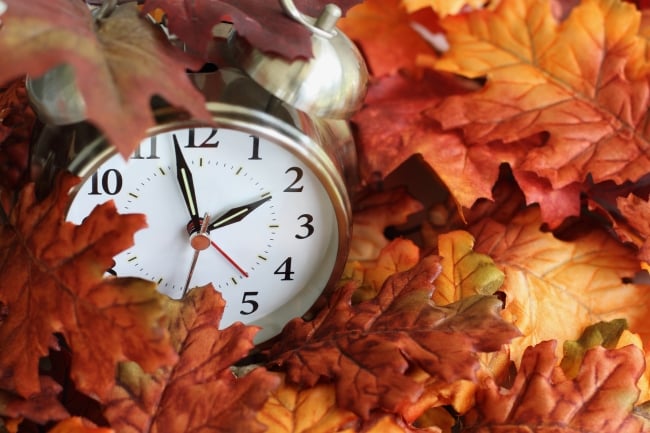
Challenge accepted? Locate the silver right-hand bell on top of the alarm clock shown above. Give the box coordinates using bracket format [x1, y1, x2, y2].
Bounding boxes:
[229, 0, 368, 119]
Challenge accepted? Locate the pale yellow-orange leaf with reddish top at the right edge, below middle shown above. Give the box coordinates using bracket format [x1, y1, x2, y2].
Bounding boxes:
[470, 207, 650, 361]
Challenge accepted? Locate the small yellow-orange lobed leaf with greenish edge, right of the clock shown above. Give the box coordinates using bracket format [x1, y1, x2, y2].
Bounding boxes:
[432, 231, 504, 305]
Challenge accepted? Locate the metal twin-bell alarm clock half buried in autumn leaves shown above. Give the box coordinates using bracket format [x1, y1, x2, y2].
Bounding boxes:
[27, 0, 368, 341]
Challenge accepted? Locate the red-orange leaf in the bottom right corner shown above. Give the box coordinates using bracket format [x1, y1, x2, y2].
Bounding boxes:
[464, 341, 647, 433]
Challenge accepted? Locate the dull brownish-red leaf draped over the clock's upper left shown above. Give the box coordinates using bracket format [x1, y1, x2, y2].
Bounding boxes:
[0, 0, 211, 155]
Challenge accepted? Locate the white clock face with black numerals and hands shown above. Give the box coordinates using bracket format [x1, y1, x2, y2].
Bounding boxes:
[68, 128, 339, 336]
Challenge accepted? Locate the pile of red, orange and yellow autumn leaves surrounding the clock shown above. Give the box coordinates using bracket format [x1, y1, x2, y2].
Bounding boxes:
[0, 0, 650, 433]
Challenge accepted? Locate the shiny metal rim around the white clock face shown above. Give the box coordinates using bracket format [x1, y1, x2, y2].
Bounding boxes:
[67, 102, 353, 343]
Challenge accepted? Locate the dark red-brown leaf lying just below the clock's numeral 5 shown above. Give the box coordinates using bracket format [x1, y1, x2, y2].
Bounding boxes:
[269, 256, 518, 419]
